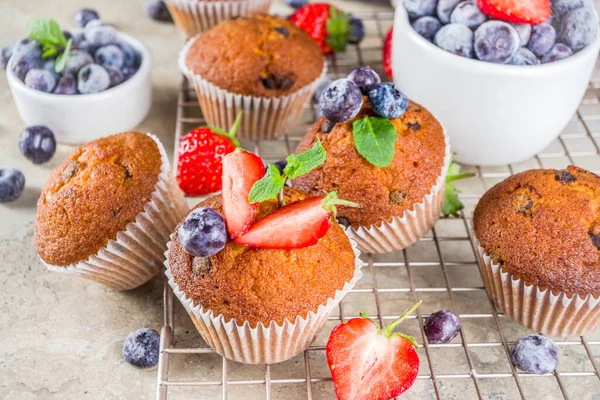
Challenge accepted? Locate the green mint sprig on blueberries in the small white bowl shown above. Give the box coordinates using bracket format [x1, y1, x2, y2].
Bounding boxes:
[27, 18, 73, 73]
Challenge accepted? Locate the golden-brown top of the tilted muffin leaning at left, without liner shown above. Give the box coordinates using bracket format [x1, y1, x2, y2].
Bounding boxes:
[35, 132, 161, 266]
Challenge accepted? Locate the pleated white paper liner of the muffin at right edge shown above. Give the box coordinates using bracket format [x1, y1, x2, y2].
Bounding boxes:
[474, 237, 600, 337]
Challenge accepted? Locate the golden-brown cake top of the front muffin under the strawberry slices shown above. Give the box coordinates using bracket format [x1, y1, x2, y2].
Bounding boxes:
[169, 189, 355, 327]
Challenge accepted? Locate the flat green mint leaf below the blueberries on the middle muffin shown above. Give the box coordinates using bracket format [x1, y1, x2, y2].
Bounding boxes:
[352, 117, 396, 168]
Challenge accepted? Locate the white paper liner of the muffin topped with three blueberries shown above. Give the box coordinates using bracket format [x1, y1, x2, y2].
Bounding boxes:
[348, 131, 451, 254]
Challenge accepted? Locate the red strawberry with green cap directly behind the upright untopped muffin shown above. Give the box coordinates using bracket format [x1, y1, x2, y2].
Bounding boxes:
[289, 3, 350, 56]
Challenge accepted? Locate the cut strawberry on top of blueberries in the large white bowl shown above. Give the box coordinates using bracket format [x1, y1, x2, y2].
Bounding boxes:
[477, 0, 552, 25]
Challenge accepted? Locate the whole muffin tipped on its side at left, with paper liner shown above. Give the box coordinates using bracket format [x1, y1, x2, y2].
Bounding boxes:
[34, 132, 187, 290]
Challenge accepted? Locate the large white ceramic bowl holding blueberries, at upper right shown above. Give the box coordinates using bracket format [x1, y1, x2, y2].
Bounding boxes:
[392, 5, 600, 165]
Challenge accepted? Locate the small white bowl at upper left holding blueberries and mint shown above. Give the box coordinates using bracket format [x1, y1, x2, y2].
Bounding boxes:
[6, 33, 152, 144]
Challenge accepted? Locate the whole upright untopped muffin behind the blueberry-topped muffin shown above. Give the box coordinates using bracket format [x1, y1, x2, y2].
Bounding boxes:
[179, 14, 326, 140]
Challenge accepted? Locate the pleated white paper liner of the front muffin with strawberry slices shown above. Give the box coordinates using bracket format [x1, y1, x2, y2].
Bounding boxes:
[165, 231, 365, 364]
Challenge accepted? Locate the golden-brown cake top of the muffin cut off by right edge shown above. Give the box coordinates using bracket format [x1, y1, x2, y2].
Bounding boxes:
[473, 166, 600, 297]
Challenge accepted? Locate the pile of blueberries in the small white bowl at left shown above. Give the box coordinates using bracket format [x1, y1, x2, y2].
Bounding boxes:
[0, 9, 141, 95]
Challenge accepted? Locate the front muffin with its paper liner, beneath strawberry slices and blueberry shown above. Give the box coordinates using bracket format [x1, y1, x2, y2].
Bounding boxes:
[166, 188, 362, 364]
